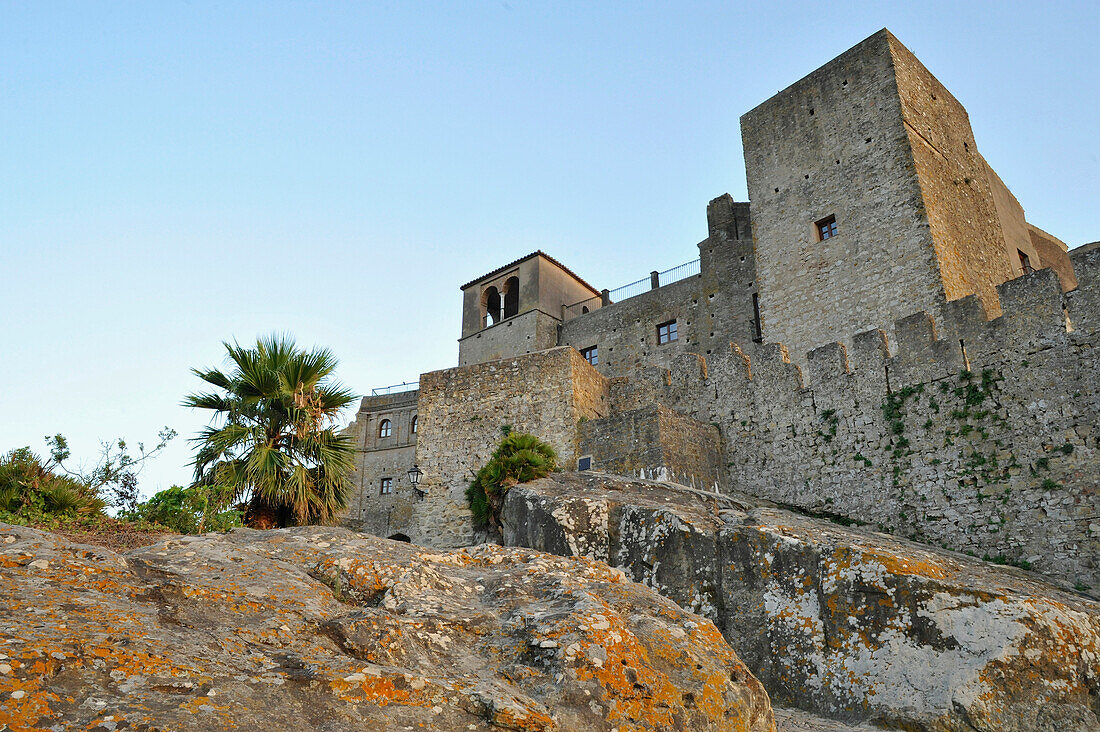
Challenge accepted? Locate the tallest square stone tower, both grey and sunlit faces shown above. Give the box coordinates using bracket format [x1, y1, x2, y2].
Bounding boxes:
[741, 30, 1069, 354]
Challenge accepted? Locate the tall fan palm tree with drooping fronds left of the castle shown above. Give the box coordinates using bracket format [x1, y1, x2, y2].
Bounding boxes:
[184, 335, 358, 526]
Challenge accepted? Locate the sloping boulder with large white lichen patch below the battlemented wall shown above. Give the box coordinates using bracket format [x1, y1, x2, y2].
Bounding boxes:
[504, 473, 1100, 732]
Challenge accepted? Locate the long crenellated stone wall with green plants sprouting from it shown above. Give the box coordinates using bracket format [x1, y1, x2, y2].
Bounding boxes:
[613, 250, 1100, 591]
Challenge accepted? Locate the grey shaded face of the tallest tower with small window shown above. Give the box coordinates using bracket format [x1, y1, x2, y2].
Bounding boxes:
[741, 31, 950, 360]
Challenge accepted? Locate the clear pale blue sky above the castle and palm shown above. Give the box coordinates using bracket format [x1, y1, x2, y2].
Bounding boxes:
[0, 0, 1100, 494]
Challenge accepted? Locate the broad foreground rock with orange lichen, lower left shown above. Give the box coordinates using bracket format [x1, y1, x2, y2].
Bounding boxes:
[0, 524, 774, 732]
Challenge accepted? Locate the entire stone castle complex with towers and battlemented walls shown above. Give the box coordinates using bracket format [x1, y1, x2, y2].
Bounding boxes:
[345, 30, 1100, 586]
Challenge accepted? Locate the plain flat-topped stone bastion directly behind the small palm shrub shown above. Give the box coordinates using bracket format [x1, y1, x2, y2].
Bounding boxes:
[409, 348, 611, 547]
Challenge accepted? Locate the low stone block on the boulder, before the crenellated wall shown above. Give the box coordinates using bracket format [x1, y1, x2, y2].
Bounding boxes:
[579, 404, 725, 491]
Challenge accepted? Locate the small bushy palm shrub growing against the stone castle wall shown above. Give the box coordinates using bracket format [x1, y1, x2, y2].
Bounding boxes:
[466, 429, 558, 535]
